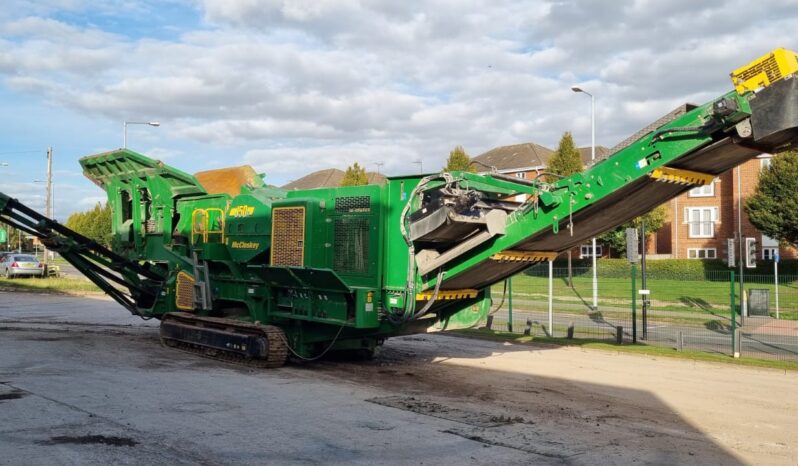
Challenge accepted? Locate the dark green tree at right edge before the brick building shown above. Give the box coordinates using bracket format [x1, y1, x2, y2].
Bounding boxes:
[745, 151, 798, 246]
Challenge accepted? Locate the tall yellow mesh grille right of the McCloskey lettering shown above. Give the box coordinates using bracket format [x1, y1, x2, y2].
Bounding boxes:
[271, 207, 305, 267]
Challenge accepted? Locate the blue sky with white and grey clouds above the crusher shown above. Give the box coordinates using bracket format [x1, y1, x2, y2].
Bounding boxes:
[0, 0, 798, 221]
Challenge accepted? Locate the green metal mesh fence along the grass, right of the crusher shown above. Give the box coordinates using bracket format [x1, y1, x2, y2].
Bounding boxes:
[491, 261, 798, 360]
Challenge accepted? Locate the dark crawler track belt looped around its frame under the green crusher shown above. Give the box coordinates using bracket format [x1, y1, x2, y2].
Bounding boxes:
[161, 312, 288, 369]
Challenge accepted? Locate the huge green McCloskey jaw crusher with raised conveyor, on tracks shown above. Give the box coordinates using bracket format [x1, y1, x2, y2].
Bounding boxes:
[0, 49, 798, 367]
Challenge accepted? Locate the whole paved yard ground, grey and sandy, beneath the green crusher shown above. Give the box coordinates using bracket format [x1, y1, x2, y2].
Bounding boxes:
[0, 293, 798, 466]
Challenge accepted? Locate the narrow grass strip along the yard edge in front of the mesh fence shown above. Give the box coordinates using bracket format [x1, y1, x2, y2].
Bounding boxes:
[448, 329, 798, 371]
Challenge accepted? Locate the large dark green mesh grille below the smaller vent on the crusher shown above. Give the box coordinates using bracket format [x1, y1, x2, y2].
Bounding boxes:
[333, 218, 370, 274]
